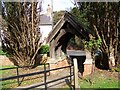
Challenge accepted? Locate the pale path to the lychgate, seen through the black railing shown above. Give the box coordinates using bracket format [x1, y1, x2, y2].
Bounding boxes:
[18, 67, 73, 90]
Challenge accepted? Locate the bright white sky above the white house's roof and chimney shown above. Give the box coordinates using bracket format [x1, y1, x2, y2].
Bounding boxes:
[43, 0, 74, 11]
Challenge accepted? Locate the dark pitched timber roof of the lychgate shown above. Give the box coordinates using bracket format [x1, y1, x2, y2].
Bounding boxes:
[47, 12, 90, 42]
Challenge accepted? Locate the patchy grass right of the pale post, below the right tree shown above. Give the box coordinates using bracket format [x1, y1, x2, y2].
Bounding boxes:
[79, 70, 120, 89]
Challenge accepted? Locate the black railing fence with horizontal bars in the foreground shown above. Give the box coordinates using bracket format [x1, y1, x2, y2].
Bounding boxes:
[0, 64, 74, 90]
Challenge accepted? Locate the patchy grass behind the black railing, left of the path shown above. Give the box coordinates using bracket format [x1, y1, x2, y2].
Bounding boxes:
[0, 65, 48, 90]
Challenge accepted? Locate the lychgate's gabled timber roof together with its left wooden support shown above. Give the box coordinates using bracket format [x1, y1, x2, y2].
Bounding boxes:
[47, 12, 89, 58]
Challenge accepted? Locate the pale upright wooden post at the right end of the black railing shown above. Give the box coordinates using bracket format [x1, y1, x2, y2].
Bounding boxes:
[73, 58, 80, 90]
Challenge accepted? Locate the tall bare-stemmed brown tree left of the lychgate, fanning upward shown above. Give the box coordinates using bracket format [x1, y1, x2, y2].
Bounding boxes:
[1, 2, 42, 66]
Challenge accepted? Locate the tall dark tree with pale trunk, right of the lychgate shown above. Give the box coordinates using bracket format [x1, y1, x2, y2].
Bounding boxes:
[71, 2, 120, 69]
